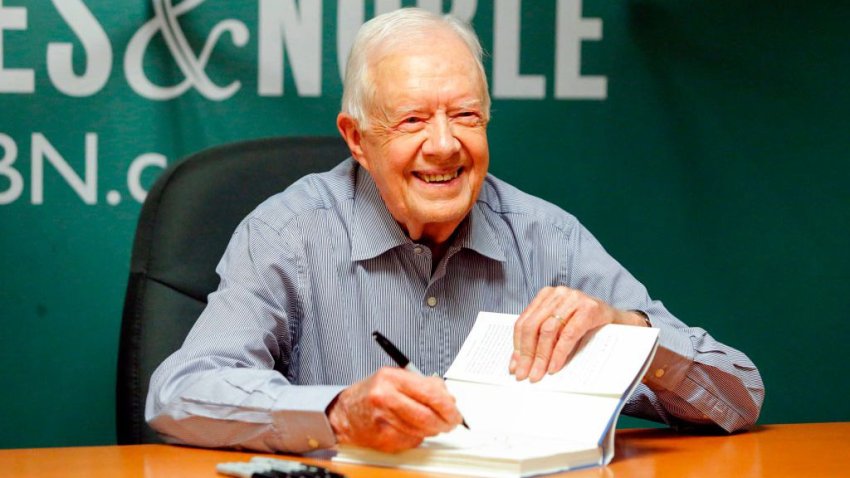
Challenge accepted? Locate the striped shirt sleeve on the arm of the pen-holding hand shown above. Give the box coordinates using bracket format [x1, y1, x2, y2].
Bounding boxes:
[145, 219, 344, 453]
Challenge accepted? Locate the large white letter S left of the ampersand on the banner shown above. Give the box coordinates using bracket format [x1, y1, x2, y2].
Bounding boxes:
[47, 0, 112, 96]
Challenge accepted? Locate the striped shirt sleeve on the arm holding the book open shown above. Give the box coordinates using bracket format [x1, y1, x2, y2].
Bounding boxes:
[565, 225, 764, 432]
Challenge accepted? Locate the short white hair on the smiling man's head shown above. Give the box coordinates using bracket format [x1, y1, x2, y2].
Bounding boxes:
[342, 8, 490, 128]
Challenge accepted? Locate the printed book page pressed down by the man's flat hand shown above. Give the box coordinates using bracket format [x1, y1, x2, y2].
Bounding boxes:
[446, 312, 658, 396]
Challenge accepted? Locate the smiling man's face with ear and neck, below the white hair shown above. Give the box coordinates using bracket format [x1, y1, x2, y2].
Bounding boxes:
[337, 17, 489, 264]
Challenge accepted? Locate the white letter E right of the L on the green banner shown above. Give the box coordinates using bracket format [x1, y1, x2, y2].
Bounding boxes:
[555, 0, 608, 99]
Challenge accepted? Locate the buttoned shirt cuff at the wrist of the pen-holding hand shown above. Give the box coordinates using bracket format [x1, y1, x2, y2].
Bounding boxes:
[273, 385, 345, 453]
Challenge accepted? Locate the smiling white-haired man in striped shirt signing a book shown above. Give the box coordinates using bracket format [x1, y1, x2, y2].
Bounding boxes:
[147, 9, 764, 452]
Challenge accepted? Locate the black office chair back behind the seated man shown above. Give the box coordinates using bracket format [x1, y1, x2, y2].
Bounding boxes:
[116, 138, 349, 445]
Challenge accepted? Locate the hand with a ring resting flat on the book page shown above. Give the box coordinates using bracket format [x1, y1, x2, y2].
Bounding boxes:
[509, 286, 646, 382]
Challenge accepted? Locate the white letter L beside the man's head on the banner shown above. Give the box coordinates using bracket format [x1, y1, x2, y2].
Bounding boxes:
[493, 0, 546, 99]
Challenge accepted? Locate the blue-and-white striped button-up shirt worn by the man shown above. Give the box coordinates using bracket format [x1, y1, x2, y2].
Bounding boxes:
[146, 159, 764, 452]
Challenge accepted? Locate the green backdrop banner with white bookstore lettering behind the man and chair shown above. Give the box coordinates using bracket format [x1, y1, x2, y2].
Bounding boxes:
[0, 0, 850, 447]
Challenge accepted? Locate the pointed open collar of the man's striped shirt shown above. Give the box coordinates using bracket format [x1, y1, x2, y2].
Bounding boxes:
[351, 165, 507, 262]
